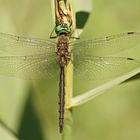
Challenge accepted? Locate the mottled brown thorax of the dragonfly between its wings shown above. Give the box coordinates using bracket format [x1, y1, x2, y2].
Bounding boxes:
[56, 35, 70, 66]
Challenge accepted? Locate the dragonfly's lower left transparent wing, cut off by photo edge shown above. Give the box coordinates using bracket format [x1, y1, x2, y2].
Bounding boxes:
[0, 54, 59, 79]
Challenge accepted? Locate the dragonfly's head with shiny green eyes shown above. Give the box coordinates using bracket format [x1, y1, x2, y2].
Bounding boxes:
[55, 23, 71, 35]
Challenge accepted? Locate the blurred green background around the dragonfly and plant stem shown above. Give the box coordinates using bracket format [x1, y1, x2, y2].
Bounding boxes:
[0, 0, 140, 140]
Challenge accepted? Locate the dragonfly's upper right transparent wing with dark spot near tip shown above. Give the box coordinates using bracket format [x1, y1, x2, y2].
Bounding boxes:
[71, 32, 140, 56]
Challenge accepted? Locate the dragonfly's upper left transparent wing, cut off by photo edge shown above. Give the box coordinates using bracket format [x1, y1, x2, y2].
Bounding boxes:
[0, 33, 56, 55]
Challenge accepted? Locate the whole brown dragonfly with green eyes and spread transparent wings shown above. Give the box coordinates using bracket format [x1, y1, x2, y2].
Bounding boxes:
[0, 29, 140, 133]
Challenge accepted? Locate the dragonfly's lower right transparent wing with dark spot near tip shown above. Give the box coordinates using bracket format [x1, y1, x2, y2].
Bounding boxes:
[74, 55, 140, 80]
